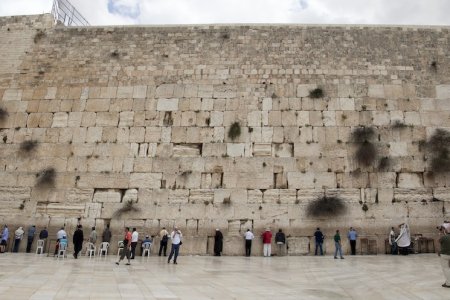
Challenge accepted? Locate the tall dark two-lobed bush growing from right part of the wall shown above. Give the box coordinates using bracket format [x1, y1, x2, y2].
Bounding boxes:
[352, 126, 377, 166]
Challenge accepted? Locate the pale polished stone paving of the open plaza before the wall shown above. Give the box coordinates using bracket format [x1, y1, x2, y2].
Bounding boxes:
[0, 253, 450, 300]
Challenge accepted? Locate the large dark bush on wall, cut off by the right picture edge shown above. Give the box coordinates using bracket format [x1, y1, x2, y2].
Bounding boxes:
[425, 128, 450, 173]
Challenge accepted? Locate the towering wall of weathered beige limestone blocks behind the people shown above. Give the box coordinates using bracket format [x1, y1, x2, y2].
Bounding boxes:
[0, 15, 450, 254]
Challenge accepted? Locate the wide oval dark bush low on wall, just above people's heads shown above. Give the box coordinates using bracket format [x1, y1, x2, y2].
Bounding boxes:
[306, 196, 346, 217]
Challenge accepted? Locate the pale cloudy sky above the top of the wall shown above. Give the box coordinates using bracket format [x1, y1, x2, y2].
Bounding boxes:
[0, 0, 450, 25]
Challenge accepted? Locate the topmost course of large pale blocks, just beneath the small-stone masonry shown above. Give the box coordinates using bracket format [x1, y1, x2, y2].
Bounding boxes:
[2, 84, 450, 101]
